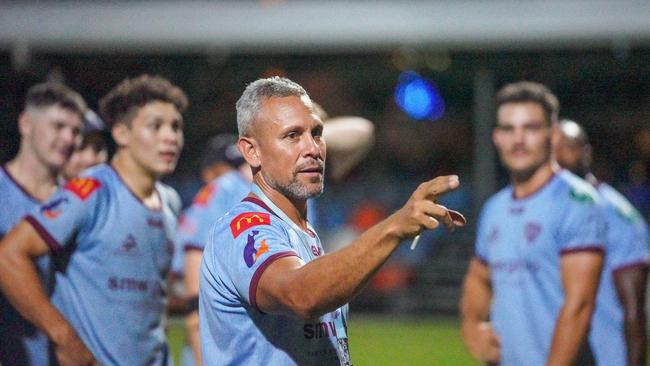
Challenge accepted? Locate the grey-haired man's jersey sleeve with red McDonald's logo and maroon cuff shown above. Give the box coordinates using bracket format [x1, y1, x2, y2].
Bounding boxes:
[218, 212, 298, 307]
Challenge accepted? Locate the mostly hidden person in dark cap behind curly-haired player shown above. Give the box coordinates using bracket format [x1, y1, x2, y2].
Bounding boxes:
[63, 109, 108, 180]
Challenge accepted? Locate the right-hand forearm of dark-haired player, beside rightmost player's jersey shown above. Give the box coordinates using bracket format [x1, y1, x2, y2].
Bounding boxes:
[546, 300, 594, 366]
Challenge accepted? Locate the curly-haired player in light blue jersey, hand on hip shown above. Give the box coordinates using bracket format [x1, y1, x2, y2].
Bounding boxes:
[0, 75, 187, 365]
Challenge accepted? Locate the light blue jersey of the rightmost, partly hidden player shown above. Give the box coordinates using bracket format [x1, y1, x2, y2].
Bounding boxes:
[589, 183, 650, 366]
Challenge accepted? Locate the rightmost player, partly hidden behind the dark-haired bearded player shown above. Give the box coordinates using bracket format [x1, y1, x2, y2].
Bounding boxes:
[553, 120, 650, 366]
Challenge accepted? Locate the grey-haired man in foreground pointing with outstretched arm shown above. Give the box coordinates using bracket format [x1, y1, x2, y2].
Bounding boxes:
[199, 77, 465, 365]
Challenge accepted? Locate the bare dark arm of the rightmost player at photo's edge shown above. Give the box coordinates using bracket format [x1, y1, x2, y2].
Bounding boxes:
[614, 264, 648, 365]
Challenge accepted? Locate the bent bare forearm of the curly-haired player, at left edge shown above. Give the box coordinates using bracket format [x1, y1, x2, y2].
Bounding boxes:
[0, 242, 73, 344]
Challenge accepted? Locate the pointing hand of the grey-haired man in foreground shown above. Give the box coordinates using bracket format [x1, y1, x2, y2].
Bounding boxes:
[392, 175, 466, 239]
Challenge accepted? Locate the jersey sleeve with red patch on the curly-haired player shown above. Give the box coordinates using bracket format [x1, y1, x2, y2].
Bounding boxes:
[25, 178, 102, 254]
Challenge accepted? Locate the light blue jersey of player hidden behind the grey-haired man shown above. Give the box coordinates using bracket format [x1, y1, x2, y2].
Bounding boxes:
[172, 170, 251, 274]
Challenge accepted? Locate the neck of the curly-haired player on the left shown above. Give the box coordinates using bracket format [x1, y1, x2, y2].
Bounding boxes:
[111, 151, 158, 204]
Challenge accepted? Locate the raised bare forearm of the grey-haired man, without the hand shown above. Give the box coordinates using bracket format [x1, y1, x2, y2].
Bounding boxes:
[280, 218, 401, 318]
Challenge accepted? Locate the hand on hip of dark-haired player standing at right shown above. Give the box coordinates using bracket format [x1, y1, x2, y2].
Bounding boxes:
[463, 322, 501, 364]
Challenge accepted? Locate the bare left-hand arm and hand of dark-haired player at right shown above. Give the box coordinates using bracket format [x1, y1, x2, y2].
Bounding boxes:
[460, 258, 501, 363]
